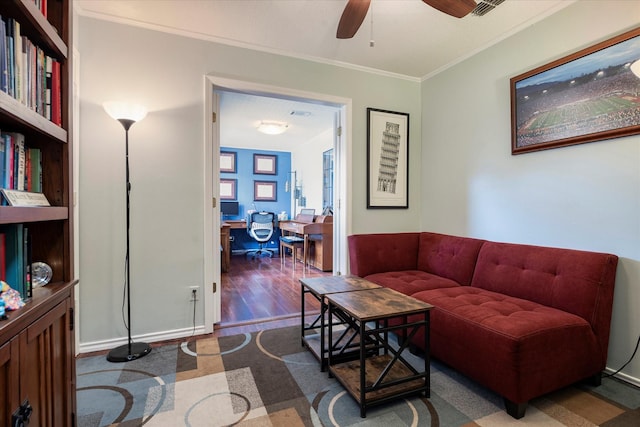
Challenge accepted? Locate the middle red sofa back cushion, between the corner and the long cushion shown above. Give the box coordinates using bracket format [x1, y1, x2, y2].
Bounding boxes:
[418, 232, 484, 285]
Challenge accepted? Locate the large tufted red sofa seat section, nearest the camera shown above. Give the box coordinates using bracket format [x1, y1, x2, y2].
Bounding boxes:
[413, 286, 603, 402]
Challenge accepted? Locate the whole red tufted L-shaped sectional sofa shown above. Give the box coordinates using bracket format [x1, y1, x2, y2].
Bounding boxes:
[348, 232, 618, 418]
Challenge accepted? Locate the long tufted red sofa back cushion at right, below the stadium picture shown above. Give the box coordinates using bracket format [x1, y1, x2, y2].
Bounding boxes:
[471, 242, 618, 358]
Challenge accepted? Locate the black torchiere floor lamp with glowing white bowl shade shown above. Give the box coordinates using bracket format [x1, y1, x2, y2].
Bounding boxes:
[103, 101, 151, 362]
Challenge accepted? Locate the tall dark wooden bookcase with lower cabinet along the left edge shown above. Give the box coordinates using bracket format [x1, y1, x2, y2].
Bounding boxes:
[0, 0, 77, 427]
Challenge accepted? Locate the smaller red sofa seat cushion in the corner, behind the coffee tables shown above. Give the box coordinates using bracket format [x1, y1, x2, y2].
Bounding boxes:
[365, 270, 460, 295]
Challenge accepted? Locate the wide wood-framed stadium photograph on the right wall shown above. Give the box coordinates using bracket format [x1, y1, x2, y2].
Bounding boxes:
[511, 28, 640, 154]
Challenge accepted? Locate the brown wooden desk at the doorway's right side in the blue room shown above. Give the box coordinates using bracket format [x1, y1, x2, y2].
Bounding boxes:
[279, 215, 333, 271]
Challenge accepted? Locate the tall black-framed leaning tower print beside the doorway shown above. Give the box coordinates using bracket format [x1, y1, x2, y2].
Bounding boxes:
[367, 108, 409, 209]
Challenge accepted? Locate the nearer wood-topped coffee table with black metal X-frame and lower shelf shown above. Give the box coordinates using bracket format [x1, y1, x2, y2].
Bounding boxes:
[326, 288, 433, 418]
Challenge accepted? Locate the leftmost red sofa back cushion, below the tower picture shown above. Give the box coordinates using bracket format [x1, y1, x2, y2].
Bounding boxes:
[347, 233, 420, 277]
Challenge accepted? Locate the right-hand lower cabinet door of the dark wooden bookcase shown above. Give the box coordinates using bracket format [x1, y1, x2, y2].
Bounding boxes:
[20, 299, 74, 427]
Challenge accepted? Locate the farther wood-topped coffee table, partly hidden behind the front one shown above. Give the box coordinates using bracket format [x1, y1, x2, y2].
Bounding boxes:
[300, 276, 381, 371]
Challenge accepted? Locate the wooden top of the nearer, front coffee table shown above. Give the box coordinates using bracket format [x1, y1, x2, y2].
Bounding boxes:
[327, 287, 433, 322]
